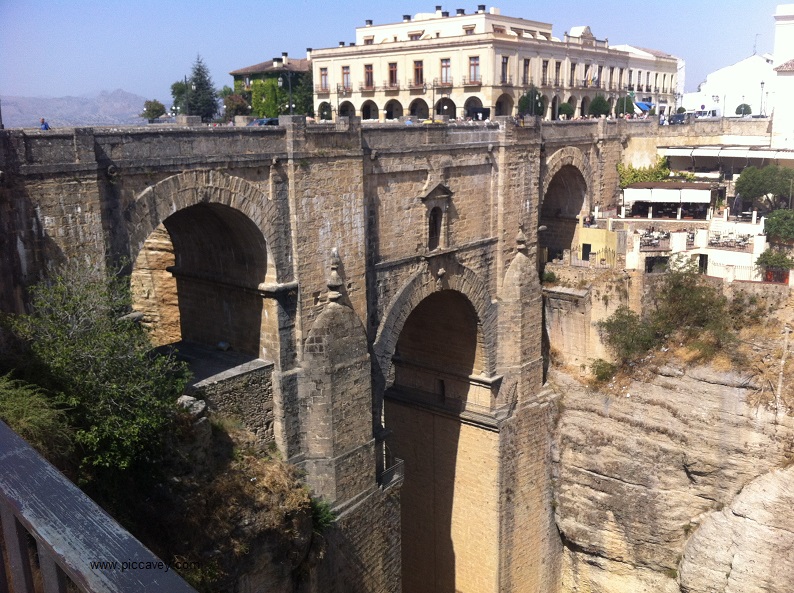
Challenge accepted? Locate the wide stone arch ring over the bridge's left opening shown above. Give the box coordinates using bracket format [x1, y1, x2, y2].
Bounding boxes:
[124, 170, 293, 283]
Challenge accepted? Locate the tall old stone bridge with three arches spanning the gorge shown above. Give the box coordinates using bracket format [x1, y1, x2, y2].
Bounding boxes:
[0, 117, 657, 593]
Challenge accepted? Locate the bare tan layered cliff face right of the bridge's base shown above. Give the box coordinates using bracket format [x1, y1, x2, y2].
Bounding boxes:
[552, 367, 794, 593]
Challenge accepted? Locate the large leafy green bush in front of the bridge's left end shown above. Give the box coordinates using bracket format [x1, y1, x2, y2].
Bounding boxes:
[12, 264, 187, 481]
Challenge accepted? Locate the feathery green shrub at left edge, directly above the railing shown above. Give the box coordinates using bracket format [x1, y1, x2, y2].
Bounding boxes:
[0, 375, 72, 459]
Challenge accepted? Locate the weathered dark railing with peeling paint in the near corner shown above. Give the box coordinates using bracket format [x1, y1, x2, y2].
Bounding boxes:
[0, 422, 196, 593]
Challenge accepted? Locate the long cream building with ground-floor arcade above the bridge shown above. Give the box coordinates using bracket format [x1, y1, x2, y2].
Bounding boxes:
[312, 5, 679, 120]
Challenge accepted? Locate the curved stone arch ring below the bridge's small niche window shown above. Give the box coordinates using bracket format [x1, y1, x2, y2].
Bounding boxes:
[373, 263, 497, 394]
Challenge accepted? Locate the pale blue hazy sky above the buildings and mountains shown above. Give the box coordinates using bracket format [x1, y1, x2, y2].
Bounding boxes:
[0, 0, 780, 106]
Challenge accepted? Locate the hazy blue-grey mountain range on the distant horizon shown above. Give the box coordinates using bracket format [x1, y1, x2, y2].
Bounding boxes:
[0, 89, 152, 128]
